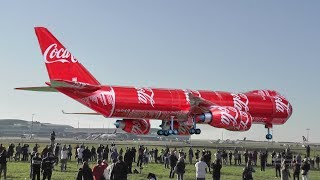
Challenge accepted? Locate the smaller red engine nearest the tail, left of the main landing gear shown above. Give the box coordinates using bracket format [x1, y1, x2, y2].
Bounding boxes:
[115, 119, 151, 134]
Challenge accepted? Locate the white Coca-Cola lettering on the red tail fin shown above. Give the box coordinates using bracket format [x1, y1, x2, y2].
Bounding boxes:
[43, 44, 78, 63]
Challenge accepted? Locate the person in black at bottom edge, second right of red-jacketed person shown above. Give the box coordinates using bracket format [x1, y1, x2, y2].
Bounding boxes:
[110, 156, 128, 180]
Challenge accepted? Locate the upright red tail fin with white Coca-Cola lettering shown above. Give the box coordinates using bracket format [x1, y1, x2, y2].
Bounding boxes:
[35, 27, 100, 85]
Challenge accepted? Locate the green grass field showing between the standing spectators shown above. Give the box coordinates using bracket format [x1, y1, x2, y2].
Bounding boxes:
[0, 143, 320, 180]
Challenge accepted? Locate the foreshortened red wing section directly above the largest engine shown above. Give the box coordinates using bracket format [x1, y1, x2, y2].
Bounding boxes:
[188, 92, 216, 114]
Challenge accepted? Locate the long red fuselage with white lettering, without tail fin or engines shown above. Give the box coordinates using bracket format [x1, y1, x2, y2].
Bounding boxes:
[58, 86, 292, 124]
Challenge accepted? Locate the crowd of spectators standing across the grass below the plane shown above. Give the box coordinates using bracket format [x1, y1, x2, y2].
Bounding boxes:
[0, 142, 320, 180]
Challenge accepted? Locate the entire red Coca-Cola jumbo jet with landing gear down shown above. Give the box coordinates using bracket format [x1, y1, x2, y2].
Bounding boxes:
[16, 27, 292, 139]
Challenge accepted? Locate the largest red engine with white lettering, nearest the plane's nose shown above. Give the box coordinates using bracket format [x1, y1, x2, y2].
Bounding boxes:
[197, 106, 252, 131]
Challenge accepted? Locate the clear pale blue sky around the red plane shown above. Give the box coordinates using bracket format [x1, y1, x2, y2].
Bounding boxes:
[0, 0, 320, 143]
